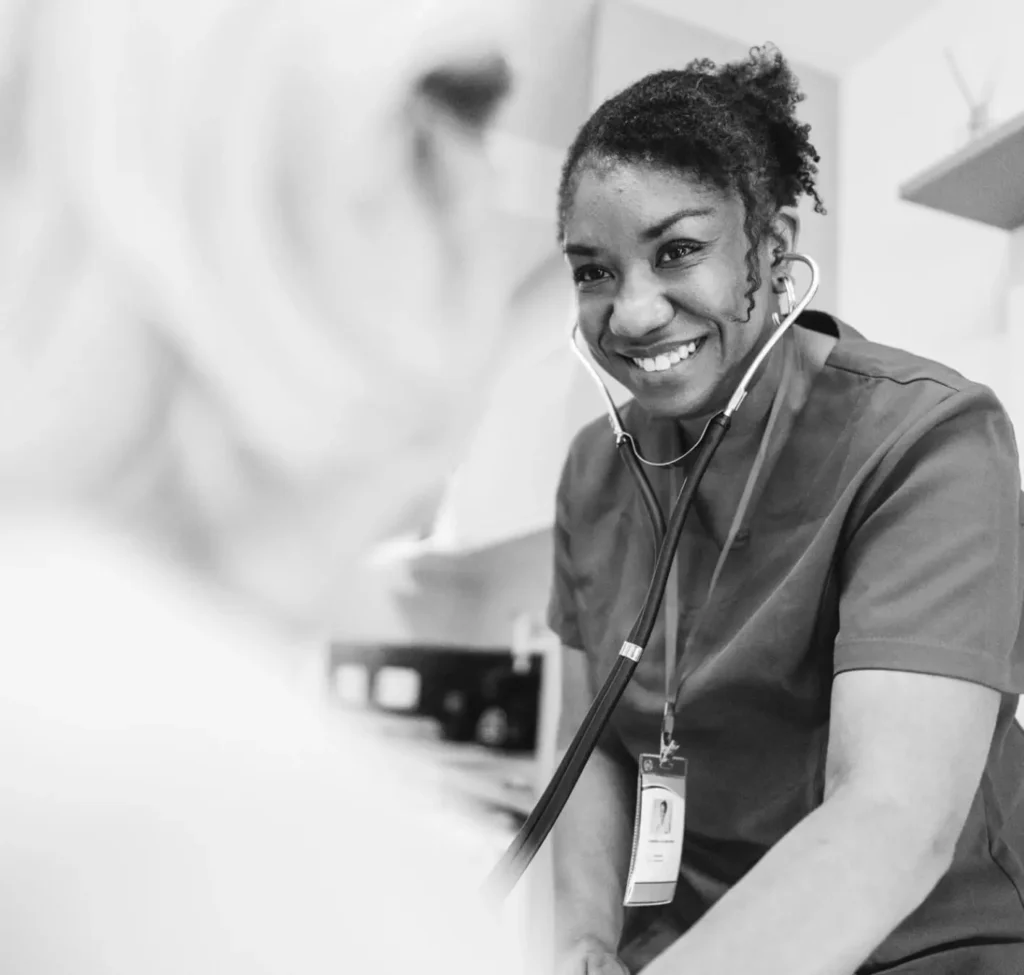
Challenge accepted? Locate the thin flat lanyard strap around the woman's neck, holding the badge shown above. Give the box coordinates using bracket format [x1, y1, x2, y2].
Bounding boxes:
[660, 341, 810, 761]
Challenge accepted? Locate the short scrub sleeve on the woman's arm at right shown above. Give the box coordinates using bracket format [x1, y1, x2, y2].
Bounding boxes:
[835, 386, 1024, 694]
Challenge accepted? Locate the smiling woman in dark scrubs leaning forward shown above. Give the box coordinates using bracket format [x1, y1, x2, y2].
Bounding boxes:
[549, 48, 1024, 975]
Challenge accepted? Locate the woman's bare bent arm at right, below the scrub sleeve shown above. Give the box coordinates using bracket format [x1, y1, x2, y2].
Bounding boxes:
[644, 670, 999, 975]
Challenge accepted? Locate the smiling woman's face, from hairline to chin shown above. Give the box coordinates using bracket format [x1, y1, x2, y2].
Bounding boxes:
[564, 164, 792, 418]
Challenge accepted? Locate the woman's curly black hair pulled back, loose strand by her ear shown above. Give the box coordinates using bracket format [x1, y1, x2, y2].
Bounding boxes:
[558, 44, 825, 319]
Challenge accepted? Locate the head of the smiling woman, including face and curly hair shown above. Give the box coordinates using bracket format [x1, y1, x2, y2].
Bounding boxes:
[558, 48, 824, 430]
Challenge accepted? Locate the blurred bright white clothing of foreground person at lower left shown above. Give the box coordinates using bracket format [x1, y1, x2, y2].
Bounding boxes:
[0, 521, 521, 975]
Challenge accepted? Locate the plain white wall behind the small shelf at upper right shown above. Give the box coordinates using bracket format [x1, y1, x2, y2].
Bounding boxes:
[838, 0, 1024, 435]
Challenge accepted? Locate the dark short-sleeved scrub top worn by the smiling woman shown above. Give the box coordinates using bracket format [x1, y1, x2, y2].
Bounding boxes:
[549, 312, 1024, 975]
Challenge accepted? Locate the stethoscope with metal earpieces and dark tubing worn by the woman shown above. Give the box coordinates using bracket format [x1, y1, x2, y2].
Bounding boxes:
[486, 253, 819, 899]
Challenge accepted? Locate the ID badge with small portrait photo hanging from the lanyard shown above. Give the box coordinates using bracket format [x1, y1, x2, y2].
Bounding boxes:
[623, 755, 686, 907]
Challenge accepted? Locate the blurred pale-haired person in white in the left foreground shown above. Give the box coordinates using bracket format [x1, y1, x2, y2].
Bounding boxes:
[0, 0, 532, 975]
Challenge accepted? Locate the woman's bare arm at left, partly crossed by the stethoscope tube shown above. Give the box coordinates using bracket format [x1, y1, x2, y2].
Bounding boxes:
[552, 648, 636, 953]
